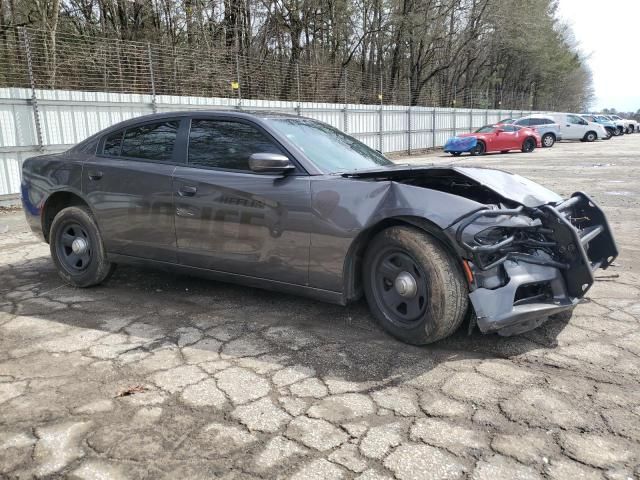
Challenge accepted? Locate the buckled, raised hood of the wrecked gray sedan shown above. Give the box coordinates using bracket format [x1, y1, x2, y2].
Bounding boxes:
[342, 165, 562, 208]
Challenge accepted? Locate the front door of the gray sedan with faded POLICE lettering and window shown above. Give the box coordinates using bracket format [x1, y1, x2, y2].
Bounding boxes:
[173, 117, 311, 285]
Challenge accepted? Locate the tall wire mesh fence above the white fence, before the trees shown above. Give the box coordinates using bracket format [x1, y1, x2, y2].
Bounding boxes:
[0, 27, 531, 110]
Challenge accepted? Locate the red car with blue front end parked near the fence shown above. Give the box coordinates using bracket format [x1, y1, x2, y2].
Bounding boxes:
[445, 124, 542, 156]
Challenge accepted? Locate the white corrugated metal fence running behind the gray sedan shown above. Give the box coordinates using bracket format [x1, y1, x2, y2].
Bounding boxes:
[0, 88, 530, 195]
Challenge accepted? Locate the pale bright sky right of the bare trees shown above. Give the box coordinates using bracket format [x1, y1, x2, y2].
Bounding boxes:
[558, 0, 640, 112]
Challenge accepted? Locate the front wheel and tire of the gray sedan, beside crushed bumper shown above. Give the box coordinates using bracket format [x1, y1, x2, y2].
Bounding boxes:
[363, 226, 469, 345]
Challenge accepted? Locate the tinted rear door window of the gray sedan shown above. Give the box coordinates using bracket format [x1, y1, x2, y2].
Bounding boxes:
[121, 121, 179, 162]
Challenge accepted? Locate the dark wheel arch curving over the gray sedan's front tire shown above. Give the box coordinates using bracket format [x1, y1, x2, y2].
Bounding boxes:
[342, 216, 462, 303]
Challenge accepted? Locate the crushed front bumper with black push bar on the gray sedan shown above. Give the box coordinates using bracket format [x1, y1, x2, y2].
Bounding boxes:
[453, 193, 618, 335]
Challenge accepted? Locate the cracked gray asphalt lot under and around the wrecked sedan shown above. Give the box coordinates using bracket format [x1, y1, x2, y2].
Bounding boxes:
[0, 135, 640, 480]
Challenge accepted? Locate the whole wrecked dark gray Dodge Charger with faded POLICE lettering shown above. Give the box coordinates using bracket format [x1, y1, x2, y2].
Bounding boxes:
[22, 111, 618, 344]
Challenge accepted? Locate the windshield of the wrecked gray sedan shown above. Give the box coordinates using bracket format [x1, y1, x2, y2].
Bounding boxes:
[265, 118, 393, 173]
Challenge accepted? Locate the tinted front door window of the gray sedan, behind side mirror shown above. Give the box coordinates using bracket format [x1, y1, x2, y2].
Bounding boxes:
[189, 120, 284, 171]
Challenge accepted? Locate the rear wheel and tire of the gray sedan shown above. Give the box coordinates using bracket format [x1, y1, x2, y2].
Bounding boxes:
[49, 206, 115, 287]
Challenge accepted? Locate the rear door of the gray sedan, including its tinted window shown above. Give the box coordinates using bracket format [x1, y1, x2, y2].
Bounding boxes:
[82, 118, 186, 262]
